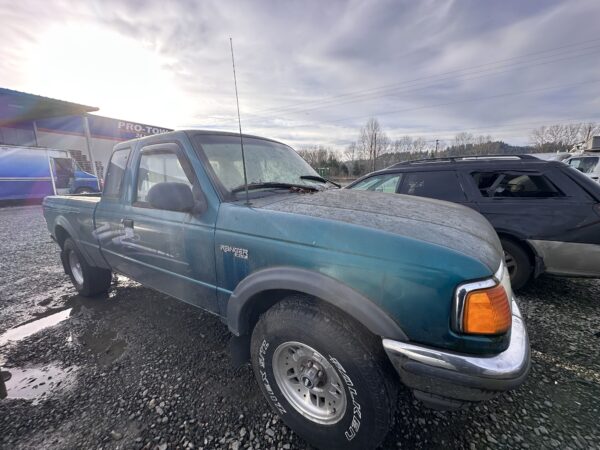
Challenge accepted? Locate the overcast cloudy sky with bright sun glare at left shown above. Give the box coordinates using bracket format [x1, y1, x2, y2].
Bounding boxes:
[0, 0, 600, 148]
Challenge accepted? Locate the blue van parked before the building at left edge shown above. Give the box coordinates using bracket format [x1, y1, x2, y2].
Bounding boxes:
[0, 146, 100, 201]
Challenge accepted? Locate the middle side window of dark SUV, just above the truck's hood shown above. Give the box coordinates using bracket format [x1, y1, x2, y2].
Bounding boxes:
[400, 171, 465, 202]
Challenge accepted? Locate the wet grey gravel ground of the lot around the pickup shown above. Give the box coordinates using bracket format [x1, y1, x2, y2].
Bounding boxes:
[0, 206, 600, 450]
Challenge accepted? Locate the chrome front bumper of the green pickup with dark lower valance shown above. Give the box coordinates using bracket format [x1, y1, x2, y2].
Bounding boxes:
[383, 299, 530, 409]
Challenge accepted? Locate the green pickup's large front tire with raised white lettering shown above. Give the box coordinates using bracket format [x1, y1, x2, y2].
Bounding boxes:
[251, 296, 399, 450]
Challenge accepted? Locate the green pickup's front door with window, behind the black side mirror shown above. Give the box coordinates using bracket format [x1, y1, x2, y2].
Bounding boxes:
[102, 143, 217, 311]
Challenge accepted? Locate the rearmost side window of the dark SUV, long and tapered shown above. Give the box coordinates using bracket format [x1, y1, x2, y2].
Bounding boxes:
[471, 172, 564, 198]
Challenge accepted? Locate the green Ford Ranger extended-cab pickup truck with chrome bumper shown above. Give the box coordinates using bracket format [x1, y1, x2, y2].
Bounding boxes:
[44, 130, 530, 449]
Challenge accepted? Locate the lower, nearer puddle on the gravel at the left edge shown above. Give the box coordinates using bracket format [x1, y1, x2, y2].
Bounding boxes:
[3, 364, 77, 404]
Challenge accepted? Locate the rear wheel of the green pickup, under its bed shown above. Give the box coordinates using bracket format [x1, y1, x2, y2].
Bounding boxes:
[61, 238, 112, 297]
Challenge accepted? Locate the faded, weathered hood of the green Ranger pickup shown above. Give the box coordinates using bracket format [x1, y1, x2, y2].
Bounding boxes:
[253, 189, 503, 272]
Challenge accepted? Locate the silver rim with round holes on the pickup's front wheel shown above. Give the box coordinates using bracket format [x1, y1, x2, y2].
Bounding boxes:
[272, 342, 347, 425]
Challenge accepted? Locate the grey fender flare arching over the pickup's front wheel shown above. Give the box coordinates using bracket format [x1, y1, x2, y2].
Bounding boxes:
[227, 267, 408, 341]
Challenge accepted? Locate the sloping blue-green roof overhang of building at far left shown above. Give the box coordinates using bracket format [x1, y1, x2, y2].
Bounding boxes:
[0, 88, 98, 126]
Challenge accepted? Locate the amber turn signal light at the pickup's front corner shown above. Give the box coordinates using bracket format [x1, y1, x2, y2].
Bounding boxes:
[463, 284, 512, 334]
